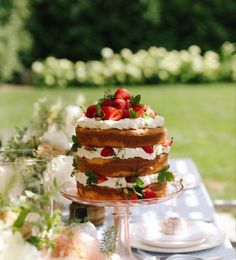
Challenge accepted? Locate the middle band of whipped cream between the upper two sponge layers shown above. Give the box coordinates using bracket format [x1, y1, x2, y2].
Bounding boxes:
[77, 144, 170, 160]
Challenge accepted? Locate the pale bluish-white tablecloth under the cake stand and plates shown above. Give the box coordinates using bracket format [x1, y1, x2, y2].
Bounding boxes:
[102, 158, 235, 260]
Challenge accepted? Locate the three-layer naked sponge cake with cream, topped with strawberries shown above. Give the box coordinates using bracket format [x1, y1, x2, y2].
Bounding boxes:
[73, 88, 174, 200]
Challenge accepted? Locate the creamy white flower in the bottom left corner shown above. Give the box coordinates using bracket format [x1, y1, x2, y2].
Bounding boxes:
[0, 229, 40, 260]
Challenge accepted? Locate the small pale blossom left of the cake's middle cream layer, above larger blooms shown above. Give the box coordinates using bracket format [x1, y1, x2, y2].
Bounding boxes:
[42, 131, 70, 151]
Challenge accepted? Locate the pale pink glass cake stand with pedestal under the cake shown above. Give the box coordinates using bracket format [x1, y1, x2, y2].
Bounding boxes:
[61, 180, 184, 260]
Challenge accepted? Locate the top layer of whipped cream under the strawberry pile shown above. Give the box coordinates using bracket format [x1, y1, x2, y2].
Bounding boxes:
[77, 115, 164, 130]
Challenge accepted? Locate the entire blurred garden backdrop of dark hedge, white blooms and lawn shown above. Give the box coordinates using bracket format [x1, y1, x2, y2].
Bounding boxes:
[0, 0, 236, 199]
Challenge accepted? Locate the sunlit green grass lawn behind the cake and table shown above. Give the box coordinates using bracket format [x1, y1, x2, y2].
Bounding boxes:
[0, 83, 236, 199]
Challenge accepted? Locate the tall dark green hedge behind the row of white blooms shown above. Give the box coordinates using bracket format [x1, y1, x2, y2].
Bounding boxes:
[29, 0, 236, 61]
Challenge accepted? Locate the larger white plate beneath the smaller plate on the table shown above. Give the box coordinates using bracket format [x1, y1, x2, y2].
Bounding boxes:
[131, 222, 226, 253]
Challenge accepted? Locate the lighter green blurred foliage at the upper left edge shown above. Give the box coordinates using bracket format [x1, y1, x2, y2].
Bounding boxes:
[0, 0, 31, 81]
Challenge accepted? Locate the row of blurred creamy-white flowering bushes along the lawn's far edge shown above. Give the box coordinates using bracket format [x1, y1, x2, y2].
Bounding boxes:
[32, 42, 236, 87]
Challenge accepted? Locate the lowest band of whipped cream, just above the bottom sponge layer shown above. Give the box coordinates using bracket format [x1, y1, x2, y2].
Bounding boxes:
[75, 172, 158, 189]
